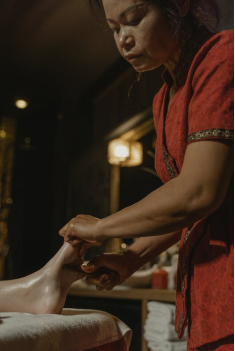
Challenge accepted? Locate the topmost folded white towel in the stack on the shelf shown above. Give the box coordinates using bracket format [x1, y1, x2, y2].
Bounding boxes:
[148, 301, 176, 324]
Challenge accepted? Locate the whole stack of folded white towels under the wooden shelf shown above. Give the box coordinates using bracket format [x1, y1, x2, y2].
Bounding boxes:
[145, 302, 187, 351]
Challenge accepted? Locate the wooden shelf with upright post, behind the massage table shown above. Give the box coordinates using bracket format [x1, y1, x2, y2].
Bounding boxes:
[69, 282, 176, 351]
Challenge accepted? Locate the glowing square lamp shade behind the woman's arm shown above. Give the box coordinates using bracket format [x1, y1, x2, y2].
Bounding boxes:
[108, 139, 143, 167]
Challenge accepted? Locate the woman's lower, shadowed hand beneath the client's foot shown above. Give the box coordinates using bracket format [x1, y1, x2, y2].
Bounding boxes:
[81, 253, 135, 291]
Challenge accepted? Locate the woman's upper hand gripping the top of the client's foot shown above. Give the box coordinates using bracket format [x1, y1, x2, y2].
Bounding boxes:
[59, 215, 104, 256]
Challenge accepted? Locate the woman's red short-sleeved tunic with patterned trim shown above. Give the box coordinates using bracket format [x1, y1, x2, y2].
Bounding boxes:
[153, 30, 234, 349]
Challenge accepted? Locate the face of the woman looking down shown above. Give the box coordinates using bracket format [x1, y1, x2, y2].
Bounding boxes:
[103, 0, 178, 72]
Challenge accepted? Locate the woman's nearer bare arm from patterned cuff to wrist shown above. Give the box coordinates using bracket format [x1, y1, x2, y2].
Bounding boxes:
[93, 141, 234, 241]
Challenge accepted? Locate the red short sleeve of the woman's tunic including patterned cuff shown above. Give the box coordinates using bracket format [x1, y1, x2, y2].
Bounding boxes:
[188, 31, 234, 144]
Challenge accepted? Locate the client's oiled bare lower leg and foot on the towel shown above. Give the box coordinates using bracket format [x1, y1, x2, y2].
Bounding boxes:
[0, 243, 82, 314]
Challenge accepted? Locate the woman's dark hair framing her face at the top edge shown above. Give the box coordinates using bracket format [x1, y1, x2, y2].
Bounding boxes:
[89, 0, 220, 38]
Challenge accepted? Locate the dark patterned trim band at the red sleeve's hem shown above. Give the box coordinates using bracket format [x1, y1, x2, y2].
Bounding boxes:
[187, 129, 234, 144]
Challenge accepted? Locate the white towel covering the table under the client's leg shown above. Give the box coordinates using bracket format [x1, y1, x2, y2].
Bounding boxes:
[0, 309, 132, 351]
